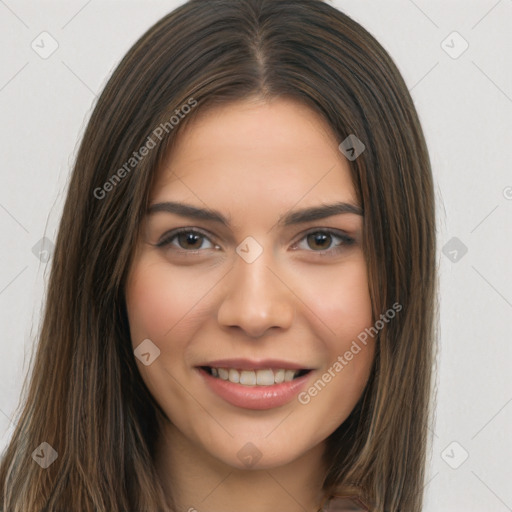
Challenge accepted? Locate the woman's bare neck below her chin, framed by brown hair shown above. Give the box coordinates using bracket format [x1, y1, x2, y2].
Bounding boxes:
[155, 424, 325, 512]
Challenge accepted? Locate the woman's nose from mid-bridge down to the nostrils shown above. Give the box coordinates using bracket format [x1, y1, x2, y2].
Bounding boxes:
[217, 253, 295, 338]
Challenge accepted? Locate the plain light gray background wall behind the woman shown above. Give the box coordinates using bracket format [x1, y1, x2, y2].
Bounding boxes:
[0, 0, 512, 512]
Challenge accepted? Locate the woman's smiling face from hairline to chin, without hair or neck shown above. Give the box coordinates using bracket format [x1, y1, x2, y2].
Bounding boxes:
[126, 99, 374, 468]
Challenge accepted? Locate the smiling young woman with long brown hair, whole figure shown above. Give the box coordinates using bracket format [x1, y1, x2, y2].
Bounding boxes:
[0, 0, 436, 512]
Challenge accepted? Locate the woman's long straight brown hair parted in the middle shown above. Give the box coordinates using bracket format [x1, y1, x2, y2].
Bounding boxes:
[0, 0, 437, 512]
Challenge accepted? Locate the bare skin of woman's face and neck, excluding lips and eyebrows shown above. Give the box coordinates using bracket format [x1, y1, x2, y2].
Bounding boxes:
[126, 98, 374, 512]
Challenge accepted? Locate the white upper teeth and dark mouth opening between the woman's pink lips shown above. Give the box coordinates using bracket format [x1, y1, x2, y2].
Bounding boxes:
[200, 366, 311, 386]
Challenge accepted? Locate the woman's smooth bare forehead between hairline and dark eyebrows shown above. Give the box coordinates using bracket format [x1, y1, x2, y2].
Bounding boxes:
[152, 99, 356, 209]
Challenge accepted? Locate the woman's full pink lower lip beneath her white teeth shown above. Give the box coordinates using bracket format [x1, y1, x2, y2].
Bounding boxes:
[198, 368, 312, 410]
